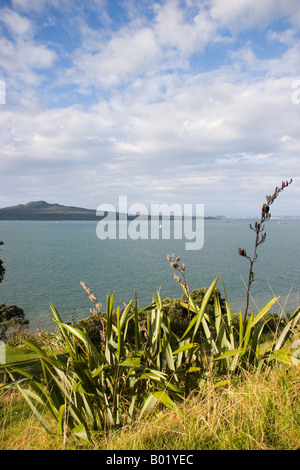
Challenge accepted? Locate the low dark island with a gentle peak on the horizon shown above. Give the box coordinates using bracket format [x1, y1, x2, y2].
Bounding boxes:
[0, 201, 225, 221]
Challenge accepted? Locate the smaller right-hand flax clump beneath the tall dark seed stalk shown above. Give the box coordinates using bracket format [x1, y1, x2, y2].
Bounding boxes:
[167, 257, 300, 385]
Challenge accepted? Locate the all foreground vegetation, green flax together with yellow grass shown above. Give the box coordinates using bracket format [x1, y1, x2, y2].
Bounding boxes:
[0, 180, 300, 450]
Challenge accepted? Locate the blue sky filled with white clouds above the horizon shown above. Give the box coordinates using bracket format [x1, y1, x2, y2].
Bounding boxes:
[0, 0, 300, 216]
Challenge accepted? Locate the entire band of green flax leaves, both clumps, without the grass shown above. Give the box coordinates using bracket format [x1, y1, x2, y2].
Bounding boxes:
[0, 274, 300, 442]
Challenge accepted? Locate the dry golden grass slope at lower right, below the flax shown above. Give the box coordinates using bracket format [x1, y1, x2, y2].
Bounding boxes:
[100, 366, 300, 450]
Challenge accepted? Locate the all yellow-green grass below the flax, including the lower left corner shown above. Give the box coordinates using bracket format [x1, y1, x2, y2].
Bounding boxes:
[0, 363, 300, 450]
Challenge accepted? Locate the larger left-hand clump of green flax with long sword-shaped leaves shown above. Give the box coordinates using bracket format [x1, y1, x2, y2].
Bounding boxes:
[2, 284, 183, 441]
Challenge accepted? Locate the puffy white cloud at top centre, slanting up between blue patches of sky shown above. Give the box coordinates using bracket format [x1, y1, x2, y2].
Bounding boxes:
[70, 2, 219, 86]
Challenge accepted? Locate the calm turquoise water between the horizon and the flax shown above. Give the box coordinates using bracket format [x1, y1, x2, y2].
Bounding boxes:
[0, 219, 300, 330]
